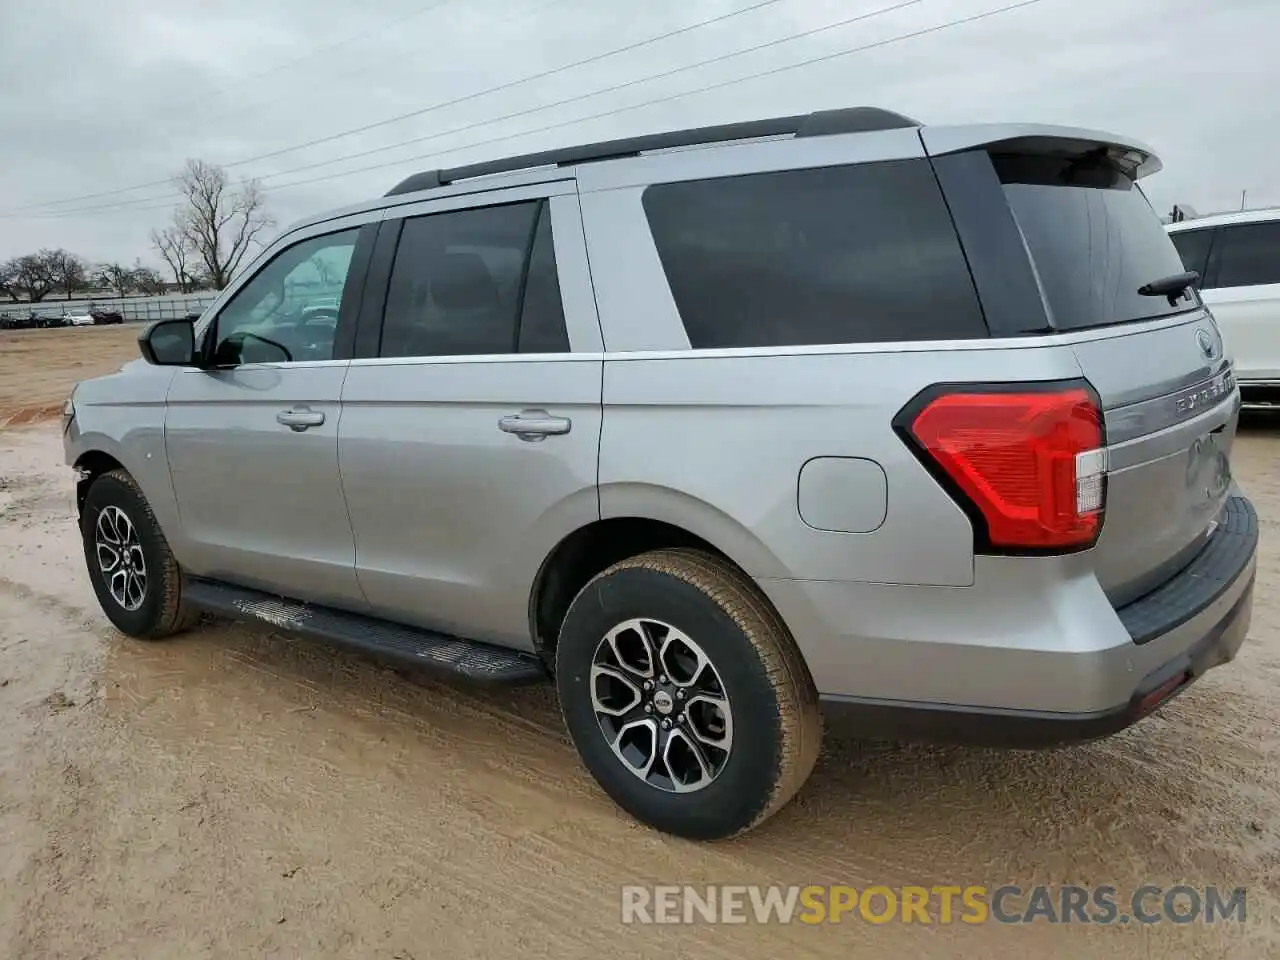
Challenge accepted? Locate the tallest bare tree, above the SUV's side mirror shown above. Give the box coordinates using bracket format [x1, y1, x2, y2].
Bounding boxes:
[177, 160, 275, 291]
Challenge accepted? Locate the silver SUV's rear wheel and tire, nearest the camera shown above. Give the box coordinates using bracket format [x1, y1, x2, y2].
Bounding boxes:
[556, 549, 822, 840]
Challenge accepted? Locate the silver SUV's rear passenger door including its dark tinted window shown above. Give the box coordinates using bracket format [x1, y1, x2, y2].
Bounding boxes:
[338, 182, 603, 649]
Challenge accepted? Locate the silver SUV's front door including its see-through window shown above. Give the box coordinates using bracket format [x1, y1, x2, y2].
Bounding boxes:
[165, 227, 376, 609]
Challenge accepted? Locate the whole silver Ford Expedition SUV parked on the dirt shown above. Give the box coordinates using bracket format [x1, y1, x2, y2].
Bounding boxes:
[65, 108, 1257, 838]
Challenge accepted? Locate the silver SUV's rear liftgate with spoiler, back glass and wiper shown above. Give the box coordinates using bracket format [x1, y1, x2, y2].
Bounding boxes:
[925, 128, 1239, 605]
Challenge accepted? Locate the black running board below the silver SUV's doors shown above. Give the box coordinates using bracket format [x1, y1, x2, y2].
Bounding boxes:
[182, 577, 547, 685]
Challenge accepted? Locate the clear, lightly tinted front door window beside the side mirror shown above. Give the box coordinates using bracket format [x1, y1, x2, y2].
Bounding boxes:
[214, 229, 360, 366]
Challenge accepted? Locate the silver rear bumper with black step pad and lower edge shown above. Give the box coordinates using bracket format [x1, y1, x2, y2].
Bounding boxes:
[762, 495, 1258, 748]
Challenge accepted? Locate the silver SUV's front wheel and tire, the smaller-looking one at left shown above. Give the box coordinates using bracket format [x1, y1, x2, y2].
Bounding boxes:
[81, 470, 200, 640]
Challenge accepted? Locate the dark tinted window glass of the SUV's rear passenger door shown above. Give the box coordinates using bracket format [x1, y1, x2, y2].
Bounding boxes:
[379, 201, 568, 357]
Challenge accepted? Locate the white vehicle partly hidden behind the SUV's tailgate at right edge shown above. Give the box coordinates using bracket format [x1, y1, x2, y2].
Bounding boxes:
[1167, 209, 1280, 406]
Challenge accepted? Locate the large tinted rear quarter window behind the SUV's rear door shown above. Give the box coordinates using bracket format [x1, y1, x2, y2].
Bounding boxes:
[644, 160, 987, 348]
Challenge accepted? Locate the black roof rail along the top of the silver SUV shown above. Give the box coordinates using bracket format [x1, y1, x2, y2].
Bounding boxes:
[385, 106, 922, 197]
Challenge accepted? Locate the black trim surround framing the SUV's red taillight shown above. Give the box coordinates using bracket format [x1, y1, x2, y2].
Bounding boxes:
[892, 376, 1107, 557]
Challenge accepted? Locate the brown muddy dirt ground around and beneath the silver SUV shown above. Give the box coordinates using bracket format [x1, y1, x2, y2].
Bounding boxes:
[0, 328, 1280, 960]
